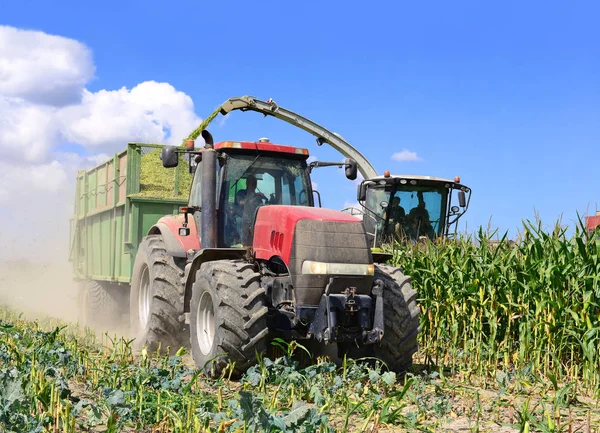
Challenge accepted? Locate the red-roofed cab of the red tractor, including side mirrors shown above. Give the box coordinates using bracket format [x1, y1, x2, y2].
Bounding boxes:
[163, 137, 356, 248]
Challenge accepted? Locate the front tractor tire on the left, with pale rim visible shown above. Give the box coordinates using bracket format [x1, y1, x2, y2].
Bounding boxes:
[190, 260, 270, 378]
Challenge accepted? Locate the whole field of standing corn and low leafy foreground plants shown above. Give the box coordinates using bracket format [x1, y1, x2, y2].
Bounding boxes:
[0, 219, 600, 433]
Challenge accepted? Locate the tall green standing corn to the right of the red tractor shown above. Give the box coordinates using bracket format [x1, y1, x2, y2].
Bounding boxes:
[394, 218, 600, 391]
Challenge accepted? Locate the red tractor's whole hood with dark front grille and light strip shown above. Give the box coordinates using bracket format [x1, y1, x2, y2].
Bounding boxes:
[254, 206, 373, 305]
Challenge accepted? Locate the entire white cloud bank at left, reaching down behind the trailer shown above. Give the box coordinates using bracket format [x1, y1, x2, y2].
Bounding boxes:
[0, 26, 201, 262]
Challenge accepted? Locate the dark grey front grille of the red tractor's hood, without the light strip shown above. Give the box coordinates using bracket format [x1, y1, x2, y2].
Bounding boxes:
[289, 220, 373, 305]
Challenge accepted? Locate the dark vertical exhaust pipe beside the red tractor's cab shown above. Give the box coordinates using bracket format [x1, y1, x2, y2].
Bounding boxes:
[200, 130, 217, 249]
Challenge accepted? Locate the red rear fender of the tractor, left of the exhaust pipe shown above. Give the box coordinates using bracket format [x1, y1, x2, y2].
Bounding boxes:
[148, 215, 200, 259]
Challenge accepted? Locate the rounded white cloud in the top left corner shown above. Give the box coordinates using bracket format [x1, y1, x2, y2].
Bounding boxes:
[0, 26, 94, 106]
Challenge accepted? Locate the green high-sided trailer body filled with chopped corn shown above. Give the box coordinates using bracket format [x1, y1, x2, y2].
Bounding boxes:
[70, 143, 192, 286]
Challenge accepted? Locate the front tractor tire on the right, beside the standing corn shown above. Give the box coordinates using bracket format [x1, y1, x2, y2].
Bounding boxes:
[373, 264, 420, 373]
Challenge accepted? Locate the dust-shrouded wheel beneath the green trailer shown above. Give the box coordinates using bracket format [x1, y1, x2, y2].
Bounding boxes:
[77, 280, 126, 331]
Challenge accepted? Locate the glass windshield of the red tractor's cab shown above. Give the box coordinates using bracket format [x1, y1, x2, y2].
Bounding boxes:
[219, 154, 313, 247]
